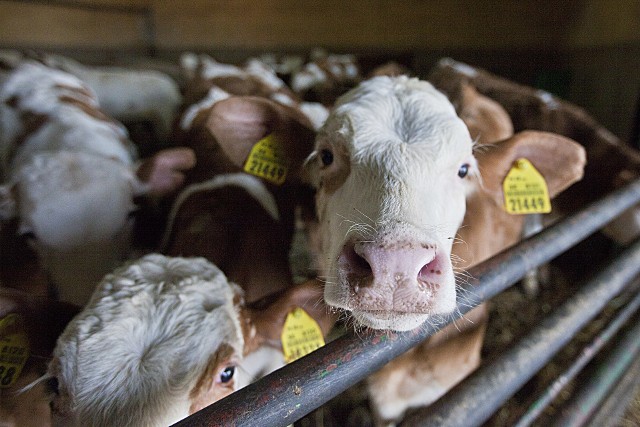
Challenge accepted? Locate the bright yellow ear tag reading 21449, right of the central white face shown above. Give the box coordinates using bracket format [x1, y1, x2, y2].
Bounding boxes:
[502, 159, 551, 215]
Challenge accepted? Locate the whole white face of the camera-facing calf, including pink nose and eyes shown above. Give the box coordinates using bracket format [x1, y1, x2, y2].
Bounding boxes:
[310, 77, 475, 330]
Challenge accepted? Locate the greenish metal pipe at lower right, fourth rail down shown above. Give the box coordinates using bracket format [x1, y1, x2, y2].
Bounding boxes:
[553, 312, 640, 427]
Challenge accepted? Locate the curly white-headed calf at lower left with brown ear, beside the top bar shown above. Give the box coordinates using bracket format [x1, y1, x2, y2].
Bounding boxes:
[48, 254, 332, 426]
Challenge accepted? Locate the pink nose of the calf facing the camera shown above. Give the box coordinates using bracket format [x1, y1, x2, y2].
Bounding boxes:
[340, 242, 444, 312]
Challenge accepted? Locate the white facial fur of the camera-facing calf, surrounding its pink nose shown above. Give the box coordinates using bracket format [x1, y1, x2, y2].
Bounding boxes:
[311, 76, 475, 330]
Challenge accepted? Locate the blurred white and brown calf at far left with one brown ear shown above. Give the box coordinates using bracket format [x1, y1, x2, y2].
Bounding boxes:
[0, 61, 194, 305]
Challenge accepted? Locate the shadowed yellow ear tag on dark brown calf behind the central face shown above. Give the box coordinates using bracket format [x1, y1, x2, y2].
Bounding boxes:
[244, 133, 289, 185]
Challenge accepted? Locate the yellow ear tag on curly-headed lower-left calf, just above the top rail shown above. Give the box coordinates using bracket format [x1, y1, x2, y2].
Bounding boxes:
[280, 307, 324, 363]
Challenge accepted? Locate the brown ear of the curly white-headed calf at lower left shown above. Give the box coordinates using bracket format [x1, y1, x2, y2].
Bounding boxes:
[244, 280, 337, 348]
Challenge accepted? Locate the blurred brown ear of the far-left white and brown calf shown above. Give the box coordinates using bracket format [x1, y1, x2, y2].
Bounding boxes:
[136, 147, 196, 196]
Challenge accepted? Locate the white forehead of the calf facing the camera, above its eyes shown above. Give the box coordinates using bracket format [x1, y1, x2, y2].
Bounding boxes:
[321, 76, 473, 162]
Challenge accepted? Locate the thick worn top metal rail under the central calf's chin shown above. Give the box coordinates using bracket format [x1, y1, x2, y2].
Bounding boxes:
[175, 180, 640, 427]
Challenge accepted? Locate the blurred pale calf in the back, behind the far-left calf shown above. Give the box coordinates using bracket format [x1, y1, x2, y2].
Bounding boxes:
[36, 53, 182, 143]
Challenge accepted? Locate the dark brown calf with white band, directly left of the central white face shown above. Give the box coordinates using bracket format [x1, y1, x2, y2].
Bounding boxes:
[161, 58, 322, 302]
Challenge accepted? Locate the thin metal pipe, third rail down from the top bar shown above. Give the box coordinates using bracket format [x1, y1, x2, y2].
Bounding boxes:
[515, 286, 640, 427]
